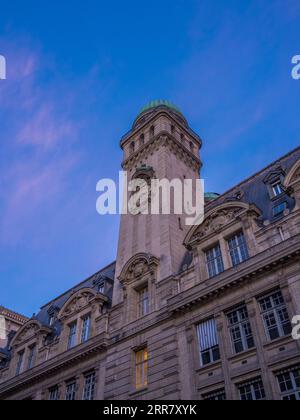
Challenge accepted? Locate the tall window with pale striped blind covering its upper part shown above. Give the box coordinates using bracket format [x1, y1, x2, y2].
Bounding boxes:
[197, 319, 220, 366]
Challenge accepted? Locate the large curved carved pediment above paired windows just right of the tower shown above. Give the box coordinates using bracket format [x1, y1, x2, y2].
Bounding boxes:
[184, 202, 261, 247]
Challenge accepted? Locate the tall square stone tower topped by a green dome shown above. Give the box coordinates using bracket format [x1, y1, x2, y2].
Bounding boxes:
[114, 101, 202, 304]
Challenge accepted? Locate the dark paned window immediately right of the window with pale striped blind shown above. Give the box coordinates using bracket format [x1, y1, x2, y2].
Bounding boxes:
[227, 306, 254, 354]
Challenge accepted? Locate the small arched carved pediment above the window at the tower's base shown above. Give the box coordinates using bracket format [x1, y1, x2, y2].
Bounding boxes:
[119, 253, 159, 283]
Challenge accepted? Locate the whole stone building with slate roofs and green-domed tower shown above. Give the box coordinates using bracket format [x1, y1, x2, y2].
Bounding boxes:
[0, 101, 300, 401]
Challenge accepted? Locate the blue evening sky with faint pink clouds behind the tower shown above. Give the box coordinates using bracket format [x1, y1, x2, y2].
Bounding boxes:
[0, 0, 300, 316]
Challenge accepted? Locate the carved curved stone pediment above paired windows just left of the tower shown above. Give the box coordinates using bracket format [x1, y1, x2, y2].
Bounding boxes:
[58, 288, 103, 319]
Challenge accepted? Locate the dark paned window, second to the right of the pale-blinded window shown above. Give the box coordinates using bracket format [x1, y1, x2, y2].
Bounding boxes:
[259, 290, 292, 341]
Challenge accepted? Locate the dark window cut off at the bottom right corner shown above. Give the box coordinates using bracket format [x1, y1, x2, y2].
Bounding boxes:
[277, 366, 300, 401]
